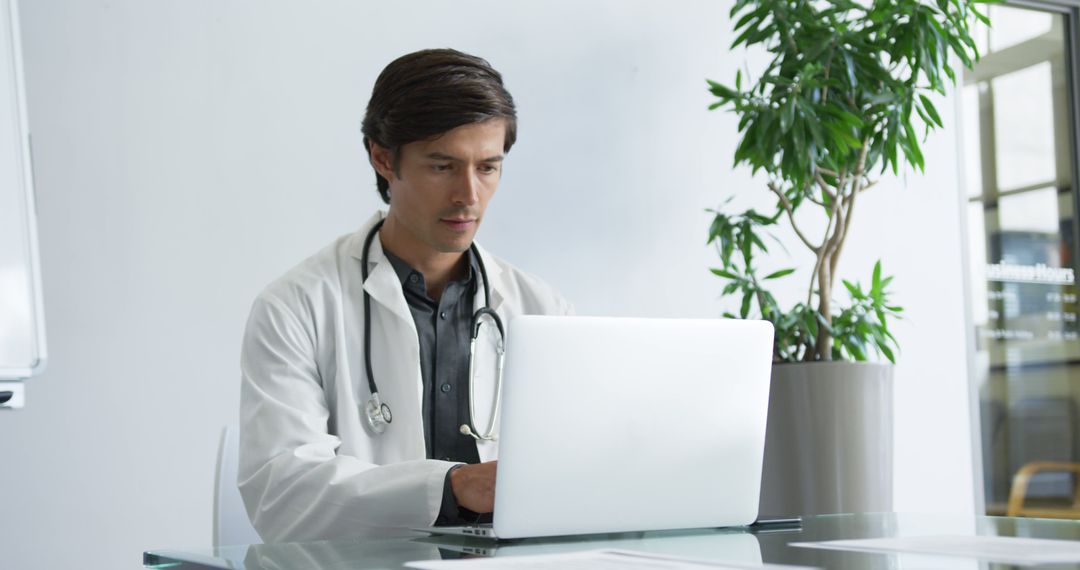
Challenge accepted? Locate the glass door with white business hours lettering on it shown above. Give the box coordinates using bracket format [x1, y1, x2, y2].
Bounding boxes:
[961, 2, 1080, 518]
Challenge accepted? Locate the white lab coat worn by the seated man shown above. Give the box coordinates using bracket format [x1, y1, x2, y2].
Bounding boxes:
[238, 213, 571, 542]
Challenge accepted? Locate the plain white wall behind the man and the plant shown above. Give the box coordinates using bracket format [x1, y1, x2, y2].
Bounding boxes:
[0, 0, 973, 568]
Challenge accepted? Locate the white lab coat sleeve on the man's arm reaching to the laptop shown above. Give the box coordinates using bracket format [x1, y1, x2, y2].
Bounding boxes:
[238, 294, 454, 542]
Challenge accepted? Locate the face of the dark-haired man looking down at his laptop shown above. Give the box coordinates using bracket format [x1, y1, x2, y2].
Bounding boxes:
[372, 119, 507, 255]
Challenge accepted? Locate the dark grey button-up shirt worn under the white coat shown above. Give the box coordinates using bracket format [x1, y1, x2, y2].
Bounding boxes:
[384, 249, 488, 524]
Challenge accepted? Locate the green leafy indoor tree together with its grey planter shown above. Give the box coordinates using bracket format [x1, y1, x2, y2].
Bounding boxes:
[708, 0, 989, 515]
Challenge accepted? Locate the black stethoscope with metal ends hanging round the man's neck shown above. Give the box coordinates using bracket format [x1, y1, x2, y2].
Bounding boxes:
[360, 219, 507, 442]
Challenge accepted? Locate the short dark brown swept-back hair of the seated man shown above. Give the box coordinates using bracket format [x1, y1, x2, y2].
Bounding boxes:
[362, 49, 517, 204]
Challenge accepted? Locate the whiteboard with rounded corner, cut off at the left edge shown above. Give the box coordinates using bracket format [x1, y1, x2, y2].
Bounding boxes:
[0, 0, 45, 380]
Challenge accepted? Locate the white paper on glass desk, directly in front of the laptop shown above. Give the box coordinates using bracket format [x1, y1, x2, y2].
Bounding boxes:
[405, 548, 812, 570]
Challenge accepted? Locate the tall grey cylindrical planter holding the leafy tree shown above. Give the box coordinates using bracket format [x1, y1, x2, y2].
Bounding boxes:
[759, 362, 893, 518]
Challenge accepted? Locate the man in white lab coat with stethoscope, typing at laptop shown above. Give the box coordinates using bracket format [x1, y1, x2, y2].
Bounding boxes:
[238, 50, 570, 542]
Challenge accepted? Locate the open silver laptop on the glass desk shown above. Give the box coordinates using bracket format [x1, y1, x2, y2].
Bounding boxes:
[423, 315, 772, 540]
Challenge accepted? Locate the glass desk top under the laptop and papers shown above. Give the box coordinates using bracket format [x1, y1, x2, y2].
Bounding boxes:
[143, 513, 1080, 570]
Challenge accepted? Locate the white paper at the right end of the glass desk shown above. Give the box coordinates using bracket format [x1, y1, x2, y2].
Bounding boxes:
[791, 537, 1080, 566]
